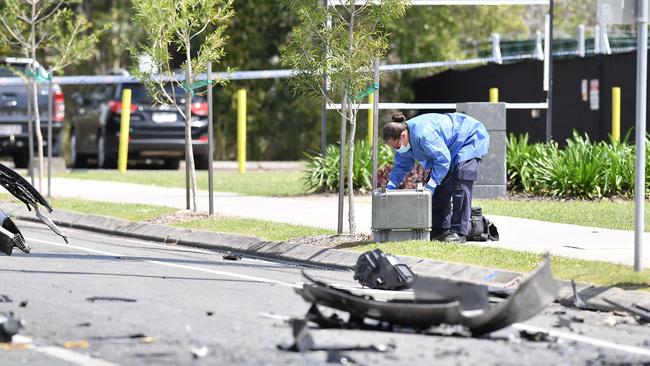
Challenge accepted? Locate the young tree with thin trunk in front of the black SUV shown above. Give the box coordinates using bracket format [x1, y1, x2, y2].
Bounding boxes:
[133, 0, 234, 211]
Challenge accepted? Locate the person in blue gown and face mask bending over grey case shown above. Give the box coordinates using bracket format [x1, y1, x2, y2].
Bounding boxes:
[383, 113, 490, 243]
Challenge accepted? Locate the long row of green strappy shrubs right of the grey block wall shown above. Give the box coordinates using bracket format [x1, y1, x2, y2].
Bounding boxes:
[506, 132, 650, 199]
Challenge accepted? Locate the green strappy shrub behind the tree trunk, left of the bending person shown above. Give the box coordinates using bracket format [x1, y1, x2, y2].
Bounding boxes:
[303, 140, 393, 192]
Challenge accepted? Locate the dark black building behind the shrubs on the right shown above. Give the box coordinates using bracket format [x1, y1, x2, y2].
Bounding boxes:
[413, 52, 650, 144]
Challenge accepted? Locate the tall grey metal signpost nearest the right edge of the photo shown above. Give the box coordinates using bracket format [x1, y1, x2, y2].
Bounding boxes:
[634, 0, 648, 272]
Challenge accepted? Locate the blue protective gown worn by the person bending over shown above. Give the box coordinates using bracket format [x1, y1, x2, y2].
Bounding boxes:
[388, 113, 490, 189]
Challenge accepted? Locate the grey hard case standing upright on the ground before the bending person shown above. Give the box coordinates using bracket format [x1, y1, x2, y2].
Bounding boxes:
[372, 187, 431, 242]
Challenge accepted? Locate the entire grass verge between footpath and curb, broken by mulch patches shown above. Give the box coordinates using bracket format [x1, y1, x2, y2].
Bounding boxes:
[5, 194, 650, 291]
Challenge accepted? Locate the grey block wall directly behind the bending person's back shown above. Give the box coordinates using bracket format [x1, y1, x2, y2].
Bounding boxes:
[456, 103, 506, 198]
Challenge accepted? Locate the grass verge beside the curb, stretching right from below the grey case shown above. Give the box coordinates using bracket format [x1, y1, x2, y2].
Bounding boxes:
[350, 241, 650, 291]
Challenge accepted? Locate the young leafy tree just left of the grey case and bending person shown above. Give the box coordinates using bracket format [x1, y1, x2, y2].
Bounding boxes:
[280, 0, 410, 234]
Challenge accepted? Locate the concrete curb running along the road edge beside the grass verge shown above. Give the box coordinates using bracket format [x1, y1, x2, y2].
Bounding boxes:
[5, 203, 650, 311]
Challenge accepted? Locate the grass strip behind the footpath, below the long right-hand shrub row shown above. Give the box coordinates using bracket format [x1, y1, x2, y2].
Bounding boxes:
[473, 199, 650, 231]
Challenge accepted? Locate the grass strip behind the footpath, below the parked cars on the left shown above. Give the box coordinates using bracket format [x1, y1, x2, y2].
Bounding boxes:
[56, 170, 305, 196]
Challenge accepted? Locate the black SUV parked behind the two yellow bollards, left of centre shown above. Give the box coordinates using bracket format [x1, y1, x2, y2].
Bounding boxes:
[68, 79, 208, 169]
